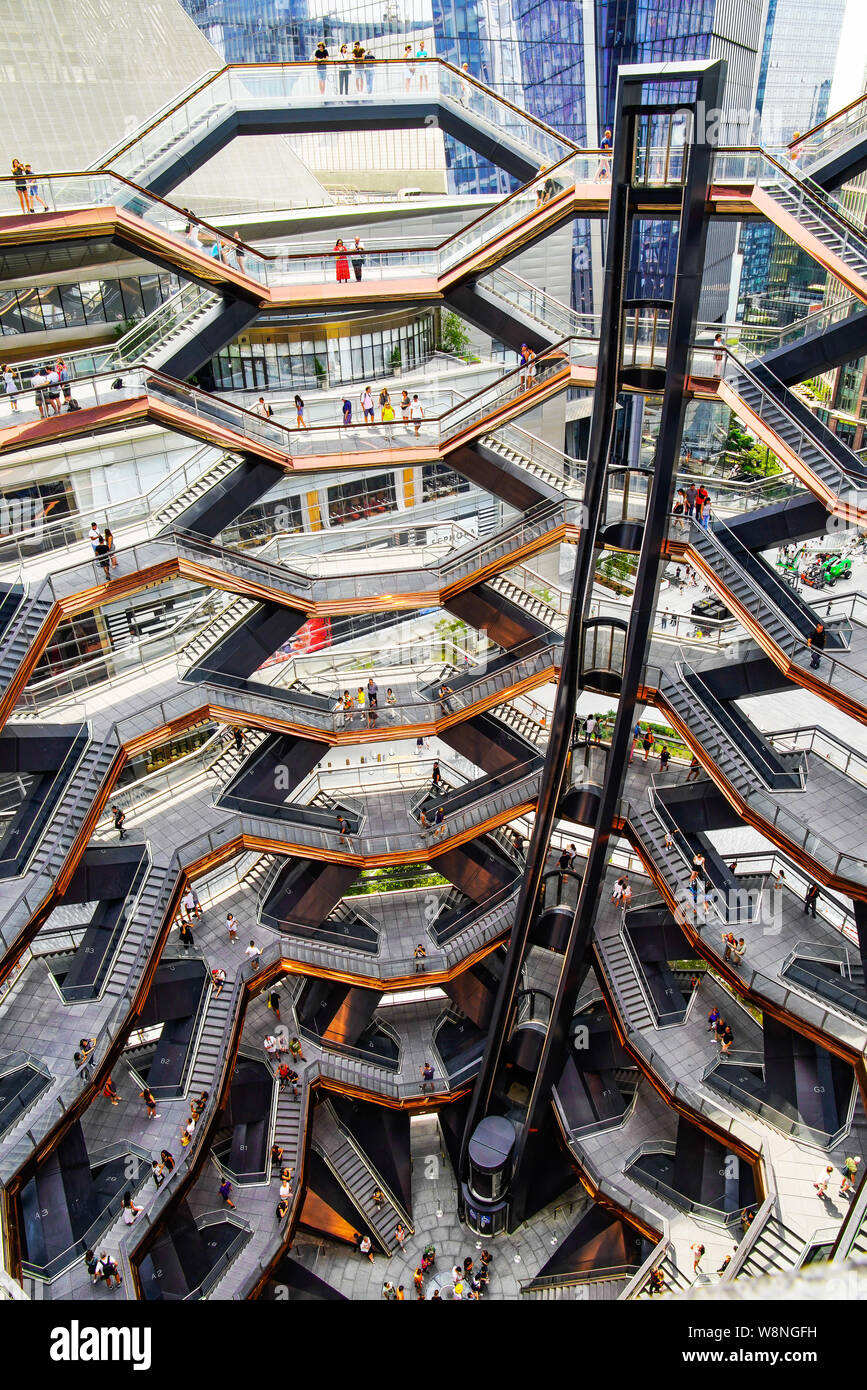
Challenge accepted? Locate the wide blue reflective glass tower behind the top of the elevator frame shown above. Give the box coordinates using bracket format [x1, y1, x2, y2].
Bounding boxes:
[174, 0, 766, 318]
